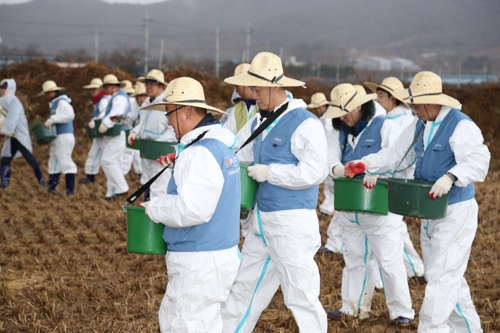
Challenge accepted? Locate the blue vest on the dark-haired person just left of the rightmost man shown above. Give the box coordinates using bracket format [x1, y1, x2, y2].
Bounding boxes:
[339, 116, 386, 178]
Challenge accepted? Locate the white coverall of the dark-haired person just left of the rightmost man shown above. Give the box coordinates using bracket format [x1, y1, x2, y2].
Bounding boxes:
[328, 116, 414, 319]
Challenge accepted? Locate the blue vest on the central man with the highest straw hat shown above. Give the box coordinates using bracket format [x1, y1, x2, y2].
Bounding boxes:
[252, 109, 319, 212]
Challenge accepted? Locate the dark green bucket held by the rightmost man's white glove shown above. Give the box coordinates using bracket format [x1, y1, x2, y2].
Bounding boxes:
[387, 178, 449, 219]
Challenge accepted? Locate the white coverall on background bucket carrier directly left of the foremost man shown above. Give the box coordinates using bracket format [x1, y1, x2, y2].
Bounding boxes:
[131, 93, 177, 199]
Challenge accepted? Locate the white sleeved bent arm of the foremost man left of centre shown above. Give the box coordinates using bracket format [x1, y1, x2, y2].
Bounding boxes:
[146, 147, 224, 228]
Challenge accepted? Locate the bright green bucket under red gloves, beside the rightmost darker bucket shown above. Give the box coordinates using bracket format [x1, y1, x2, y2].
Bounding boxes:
[333, 178, 389, 215]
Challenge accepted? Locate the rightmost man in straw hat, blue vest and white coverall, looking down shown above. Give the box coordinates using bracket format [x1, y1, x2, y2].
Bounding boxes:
[346, 72, 490, 333]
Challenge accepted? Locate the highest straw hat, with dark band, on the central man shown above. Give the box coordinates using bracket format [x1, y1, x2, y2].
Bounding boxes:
[224, 52, 305, 87]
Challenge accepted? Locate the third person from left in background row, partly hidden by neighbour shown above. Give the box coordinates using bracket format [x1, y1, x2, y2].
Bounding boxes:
[78, 78, 109, 184]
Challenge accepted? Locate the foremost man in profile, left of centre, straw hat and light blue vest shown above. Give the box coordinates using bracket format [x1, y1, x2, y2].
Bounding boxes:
[142, 77, 241, 333]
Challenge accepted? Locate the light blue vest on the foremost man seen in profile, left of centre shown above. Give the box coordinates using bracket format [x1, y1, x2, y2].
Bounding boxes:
[163, 139, 241, 252]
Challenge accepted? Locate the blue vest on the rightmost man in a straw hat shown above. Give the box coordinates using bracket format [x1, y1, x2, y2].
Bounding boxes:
[415, 109, 474, 205]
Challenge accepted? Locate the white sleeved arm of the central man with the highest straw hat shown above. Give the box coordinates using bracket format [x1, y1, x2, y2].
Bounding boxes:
[267, 118, 328, 190]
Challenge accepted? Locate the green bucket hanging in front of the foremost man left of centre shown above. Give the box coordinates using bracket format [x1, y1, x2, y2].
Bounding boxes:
[123, 206, 167, 254]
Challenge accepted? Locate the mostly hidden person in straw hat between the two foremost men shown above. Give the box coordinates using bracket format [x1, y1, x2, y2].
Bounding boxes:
[224, 63, 259, 134]
